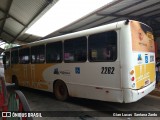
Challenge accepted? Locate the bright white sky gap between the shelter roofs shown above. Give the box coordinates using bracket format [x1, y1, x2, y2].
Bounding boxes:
[26, 0, 113, 37]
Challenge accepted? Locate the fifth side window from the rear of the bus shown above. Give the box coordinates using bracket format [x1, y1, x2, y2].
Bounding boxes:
[19, 48, 30, 64]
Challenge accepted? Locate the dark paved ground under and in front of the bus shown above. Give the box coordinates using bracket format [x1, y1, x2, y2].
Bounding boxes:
[22, 87, 160, 120]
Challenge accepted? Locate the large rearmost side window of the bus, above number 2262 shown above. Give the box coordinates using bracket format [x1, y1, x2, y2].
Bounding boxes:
[88, 31, 117, 62]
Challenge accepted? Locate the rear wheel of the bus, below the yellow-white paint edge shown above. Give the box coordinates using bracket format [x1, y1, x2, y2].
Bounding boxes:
[54, 80, 69, 101]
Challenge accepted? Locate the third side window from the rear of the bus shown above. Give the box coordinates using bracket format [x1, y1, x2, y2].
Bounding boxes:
[46, 42, 62, 63]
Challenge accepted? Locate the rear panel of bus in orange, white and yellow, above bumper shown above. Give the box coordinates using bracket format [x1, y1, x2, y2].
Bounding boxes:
[130, 21, 155, 89]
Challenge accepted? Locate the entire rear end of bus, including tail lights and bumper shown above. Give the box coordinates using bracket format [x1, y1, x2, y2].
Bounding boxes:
[124, 21, 156, 103]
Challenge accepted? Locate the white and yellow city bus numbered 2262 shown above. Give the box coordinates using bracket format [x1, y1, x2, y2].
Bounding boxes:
[3, 20, 155, 103]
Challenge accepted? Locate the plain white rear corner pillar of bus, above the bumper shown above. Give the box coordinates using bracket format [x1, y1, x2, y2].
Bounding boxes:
[118, 22, 133, 89]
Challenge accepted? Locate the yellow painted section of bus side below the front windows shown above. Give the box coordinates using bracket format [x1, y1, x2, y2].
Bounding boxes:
[9, 64, 53, 91]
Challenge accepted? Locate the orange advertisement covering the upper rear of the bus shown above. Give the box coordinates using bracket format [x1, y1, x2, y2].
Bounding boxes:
[130, 21, 155, 52]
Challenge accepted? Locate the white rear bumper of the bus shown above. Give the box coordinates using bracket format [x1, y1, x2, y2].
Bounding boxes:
[124, 82, 156, 103]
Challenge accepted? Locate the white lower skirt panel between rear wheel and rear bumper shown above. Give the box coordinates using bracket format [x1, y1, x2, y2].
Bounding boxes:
[67, 84, 123, 103]
